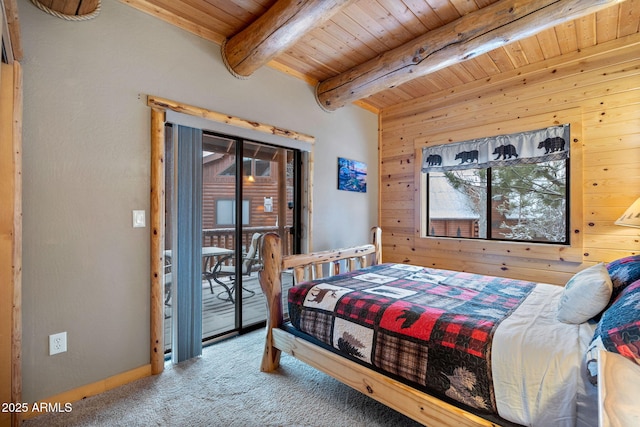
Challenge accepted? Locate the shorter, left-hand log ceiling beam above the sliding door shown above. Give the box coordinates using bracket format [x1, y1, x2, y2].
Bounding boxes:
[222, 0, 352, 77]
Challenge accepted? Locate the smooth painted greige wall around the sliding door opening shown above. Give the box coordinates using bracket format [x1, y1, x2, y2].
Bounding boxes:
[18, 0, 378, 401]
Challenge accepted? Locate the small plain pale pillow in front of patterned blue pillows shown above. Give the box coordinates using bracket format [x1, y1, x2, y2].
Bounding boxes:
[556, 263, 613, 324]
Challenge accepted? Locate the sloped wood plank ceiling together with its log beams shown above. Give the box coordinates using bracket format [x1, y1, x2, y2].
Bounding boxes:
[22, 0, 640, 111]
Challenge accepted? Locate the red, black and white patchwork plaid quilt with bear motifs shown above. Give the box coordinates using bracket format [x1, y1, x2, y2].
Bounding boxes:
[288, 264, 535, 413]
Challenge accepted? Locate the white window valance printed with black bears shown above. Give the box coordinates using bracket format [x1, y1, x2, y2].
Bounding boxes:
[422, 124, 570, 172]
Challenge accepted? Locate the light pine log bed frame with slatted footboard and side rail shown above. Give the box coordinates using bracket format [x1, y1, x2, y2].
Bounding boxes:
[259, 227, 498, 427]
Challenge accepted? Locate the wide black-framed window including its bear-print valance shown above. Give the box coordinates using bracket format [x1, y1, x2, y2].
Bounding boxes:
[422, 125, 569, 244]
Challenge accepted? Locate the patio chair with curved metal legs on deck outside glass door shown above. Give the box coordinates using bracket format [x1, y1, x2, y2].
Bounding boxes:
[207, 233, 262, 302]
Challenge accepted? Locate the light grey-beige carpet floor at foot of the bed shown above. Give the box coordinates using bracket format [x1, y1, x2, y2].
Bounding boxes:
[24, 330, 418, 427]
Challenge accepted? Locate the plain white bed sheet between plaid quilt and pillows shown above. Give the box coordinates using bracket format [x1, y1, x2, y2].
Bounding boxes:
[491, 283, 597, 427]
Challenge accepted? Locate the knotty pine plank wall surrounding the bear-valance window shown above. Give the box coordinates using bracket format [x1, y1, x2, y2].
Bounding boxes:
[379, 34, 640, 284]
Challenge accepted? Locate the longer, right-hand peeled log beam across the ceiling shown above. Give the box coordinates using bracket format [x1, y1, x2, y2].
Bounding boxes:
[316, 0, 622, 111]
